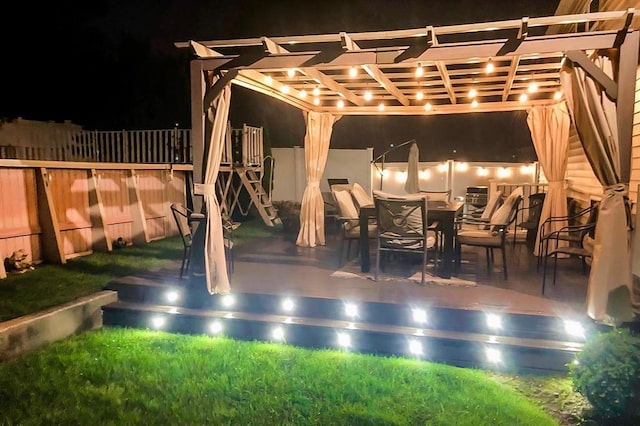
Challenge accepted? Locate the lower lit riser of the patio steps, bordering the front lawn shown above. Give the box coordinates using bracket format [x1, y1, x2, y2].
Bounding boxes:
[103, 306, 574, 373]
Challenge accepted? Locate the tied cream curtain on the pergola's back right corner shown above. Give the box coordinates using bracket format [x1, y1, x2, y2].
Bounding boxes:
[527, 103, 570, 255]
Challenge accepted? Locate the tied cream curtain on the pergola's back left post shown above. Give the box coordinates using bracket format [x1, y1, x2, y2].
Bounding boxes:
[296, 111, 340, 247]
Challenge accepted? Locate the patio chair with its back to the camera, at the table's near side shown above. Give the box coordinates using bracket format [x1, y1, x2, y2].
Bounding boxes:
[373, 191, 438, 285]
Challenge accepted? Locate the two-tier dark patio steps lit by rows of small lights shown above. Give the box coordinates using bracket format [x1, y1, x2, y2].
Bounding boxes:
[103, 276, 583, 373]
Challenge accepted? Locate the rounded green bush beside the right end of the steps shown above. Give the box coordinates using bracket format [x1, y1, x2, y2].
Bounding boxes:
[569, 329, 640, 418]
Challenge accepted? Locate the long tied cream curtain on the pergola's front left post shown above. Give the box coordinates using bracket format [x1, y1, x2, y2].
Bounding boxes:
[195, 83, 231, 294]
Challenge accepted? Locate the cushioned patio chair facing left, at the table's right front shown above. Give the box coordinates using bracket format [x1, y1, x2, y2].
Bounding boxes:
[454, 187, 522, 280]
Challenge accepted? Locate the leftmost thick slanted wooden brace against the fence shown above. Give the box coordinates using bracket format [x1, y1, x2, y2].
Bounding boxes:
[36, 167, 67, 264]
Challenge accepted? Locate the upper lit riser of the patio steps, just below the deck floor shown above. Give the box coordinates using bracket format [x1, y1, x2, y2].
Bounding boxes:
[109, 282, 592, 342]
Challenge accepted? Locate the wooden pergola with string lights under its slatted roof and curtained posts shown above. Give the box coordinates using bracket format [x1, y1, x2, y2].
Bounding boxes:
[176, 9, 640, 319]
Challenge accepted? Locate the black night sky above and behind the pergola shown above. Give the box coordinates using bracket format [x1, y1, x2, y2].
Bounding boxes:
[0, 0, 558, 161]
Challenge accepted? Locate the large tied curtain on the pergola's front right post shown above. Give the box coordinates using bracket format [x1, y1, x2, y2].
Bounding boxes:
[560, 57, 633, 324]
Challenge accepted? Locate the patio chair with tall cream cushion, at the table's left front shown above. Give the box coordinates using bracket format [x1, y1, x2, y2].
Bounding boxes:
[331, 185, 376, 264]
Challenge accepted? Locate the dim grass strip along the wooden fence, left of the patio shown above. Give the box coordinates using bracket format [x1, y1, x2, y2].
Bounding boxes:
[0, 218, 277, 322]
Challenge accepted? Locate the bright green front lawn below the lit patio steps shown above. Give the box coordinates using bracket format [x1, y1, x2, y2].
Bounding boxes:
[0, 329, 558, 426]
